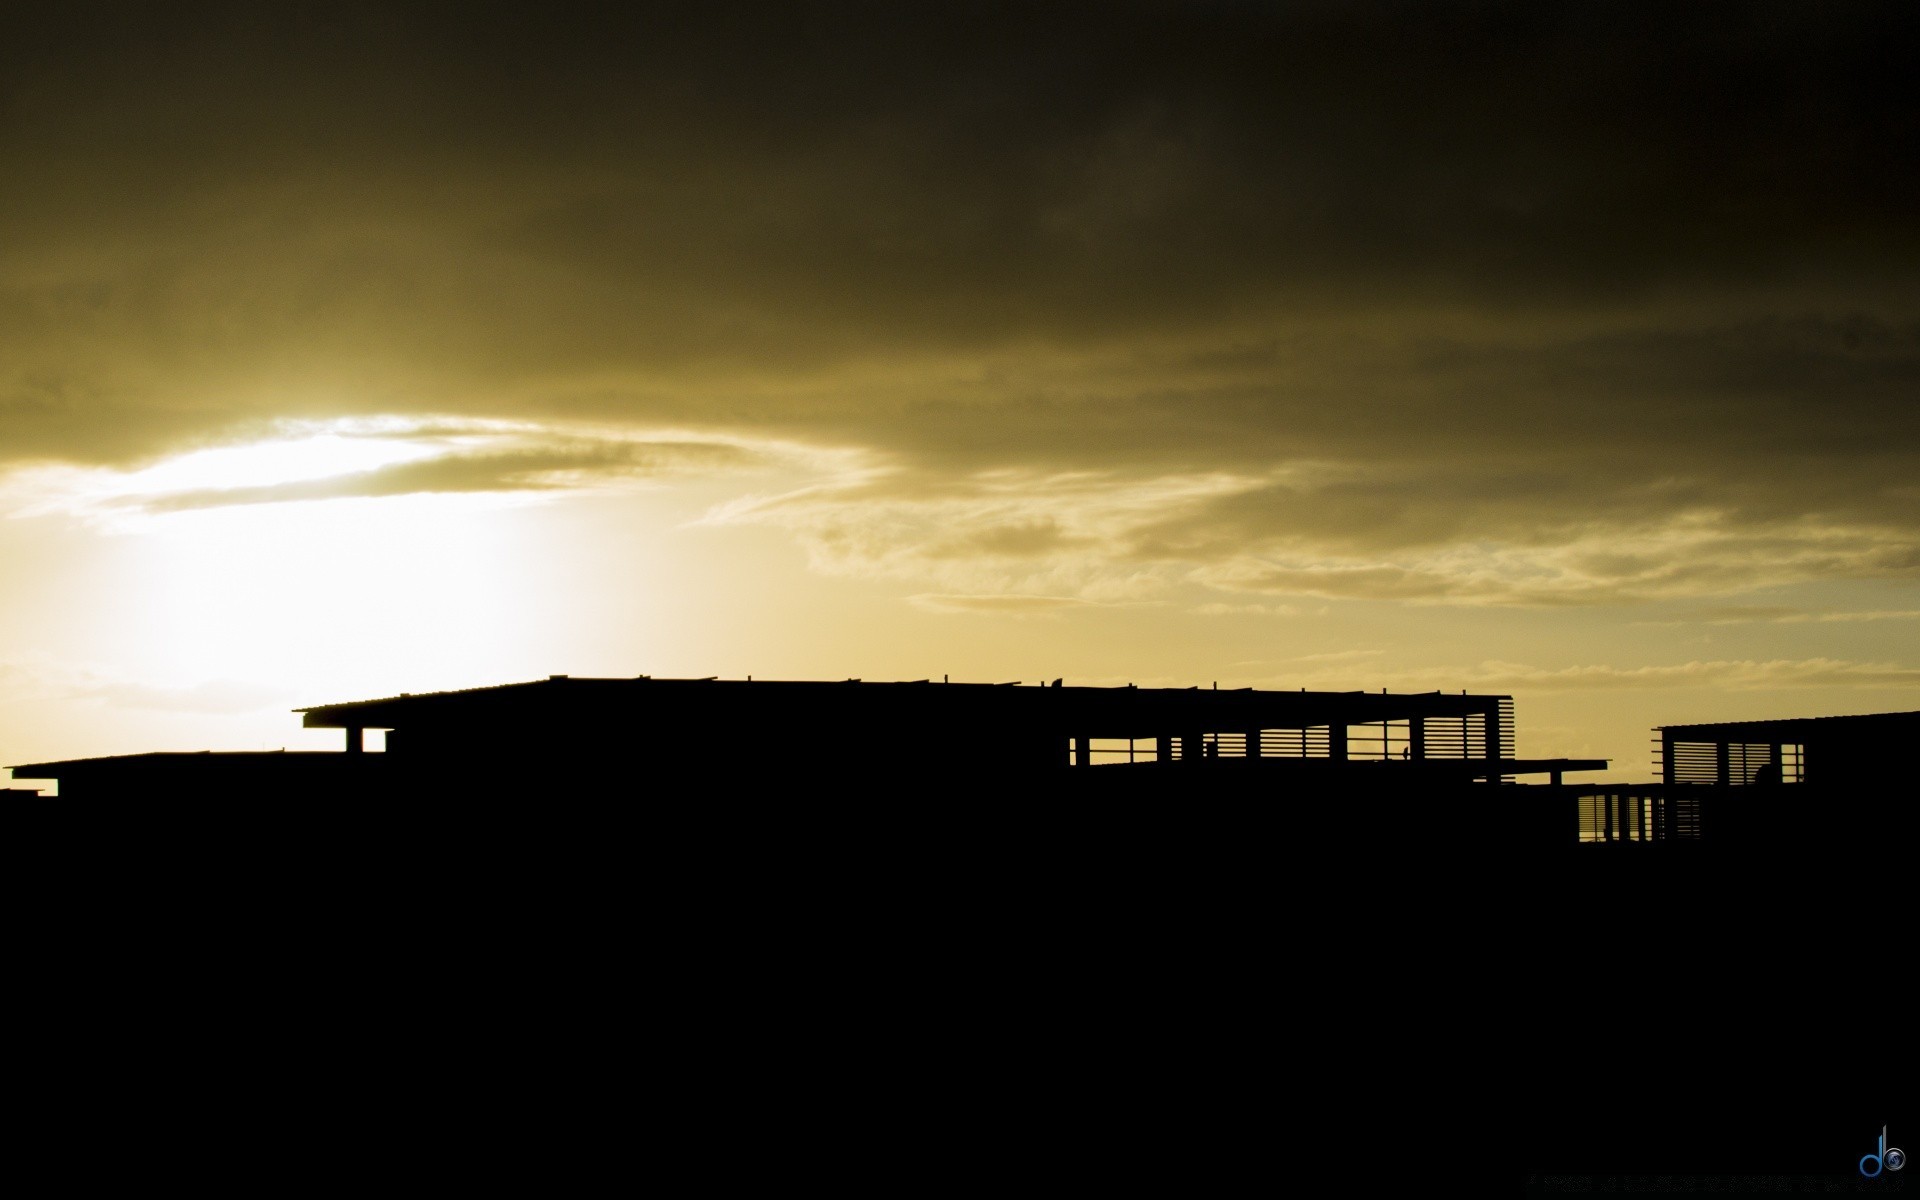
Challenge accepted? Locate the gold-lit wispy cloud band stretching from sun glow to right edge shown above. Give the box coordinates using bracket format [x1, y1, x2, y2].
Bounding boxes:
[712, 447, 1920, 612]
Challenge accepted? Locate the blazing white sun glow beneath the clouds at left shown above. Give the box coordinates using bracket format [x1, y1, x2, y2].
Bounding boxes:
[0, 417, 847, 755]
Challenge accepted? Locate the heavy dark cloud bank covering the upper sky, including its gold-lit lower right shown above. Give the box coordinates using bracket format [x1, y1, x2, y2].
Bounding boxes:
[0, 2, 1920, 599]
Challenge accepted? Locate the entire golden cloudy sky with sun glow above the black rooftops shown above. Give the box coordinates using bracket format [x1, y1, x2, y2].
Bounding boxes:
[0, 0, 1920, 780]
